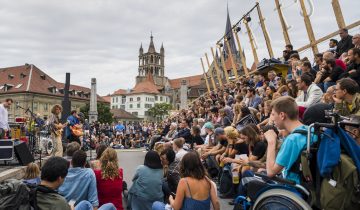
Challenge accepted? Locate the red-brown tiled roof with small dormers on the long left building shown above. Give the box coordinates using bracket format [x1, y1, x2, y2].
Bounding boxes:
[0, 64, 105, 102]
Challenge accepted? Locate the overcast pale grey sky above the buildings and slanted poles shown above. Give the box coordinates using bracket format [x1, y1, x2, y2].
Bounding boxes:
[0, 0, 360, 95]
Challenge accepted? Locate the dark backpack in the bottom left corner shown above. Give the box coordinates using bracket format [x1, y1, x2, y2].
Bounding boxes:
[0, 179, 38, 210]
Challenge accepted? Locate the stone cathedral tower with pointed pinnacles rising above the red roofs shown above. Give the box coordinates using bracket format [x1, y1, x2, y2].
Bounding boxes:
[136, 34, 167, 87]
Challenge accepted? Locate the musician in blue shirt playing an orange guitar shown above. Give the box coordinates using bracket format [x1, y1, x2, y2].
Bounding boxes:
[66, 110, 83, 145]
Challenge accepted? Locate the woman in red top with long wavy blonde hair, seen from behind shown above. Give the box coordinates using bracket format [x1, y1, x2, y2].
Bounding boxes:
[94, 148, 124, 210]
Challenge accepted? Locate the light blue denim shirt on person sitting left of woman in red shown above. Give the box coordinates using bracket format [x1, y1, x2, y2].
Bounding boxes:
[58, 167, 99, 207]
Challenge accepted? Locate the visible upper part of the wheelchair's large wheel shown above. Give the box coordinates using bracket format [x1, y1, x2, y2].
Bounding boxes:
[253, 189, 312, 210]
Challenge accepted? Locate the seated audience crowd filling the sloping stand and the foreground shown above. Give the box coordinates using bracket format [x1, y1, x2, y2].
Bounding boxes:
[2, 29, 360, 210]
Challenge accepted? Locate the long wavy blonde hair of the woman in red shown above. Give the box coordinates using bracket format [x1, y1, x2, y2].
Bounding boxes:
[100, 148, 122, 180]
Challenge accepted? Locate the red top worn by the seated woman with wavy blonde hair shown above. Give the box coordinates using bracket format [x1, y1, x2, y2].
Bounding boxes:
[94, 168, 124, 210]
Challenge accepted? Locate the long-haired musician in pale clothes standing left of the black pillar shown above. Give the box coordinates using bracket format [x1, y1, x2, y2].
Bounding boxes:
[48, 104, 66, 157]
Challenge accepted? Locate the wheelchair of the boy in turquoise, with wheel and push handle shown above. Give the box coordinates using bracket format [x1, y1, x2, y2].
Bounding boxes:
[234, 113, 360, 210]
